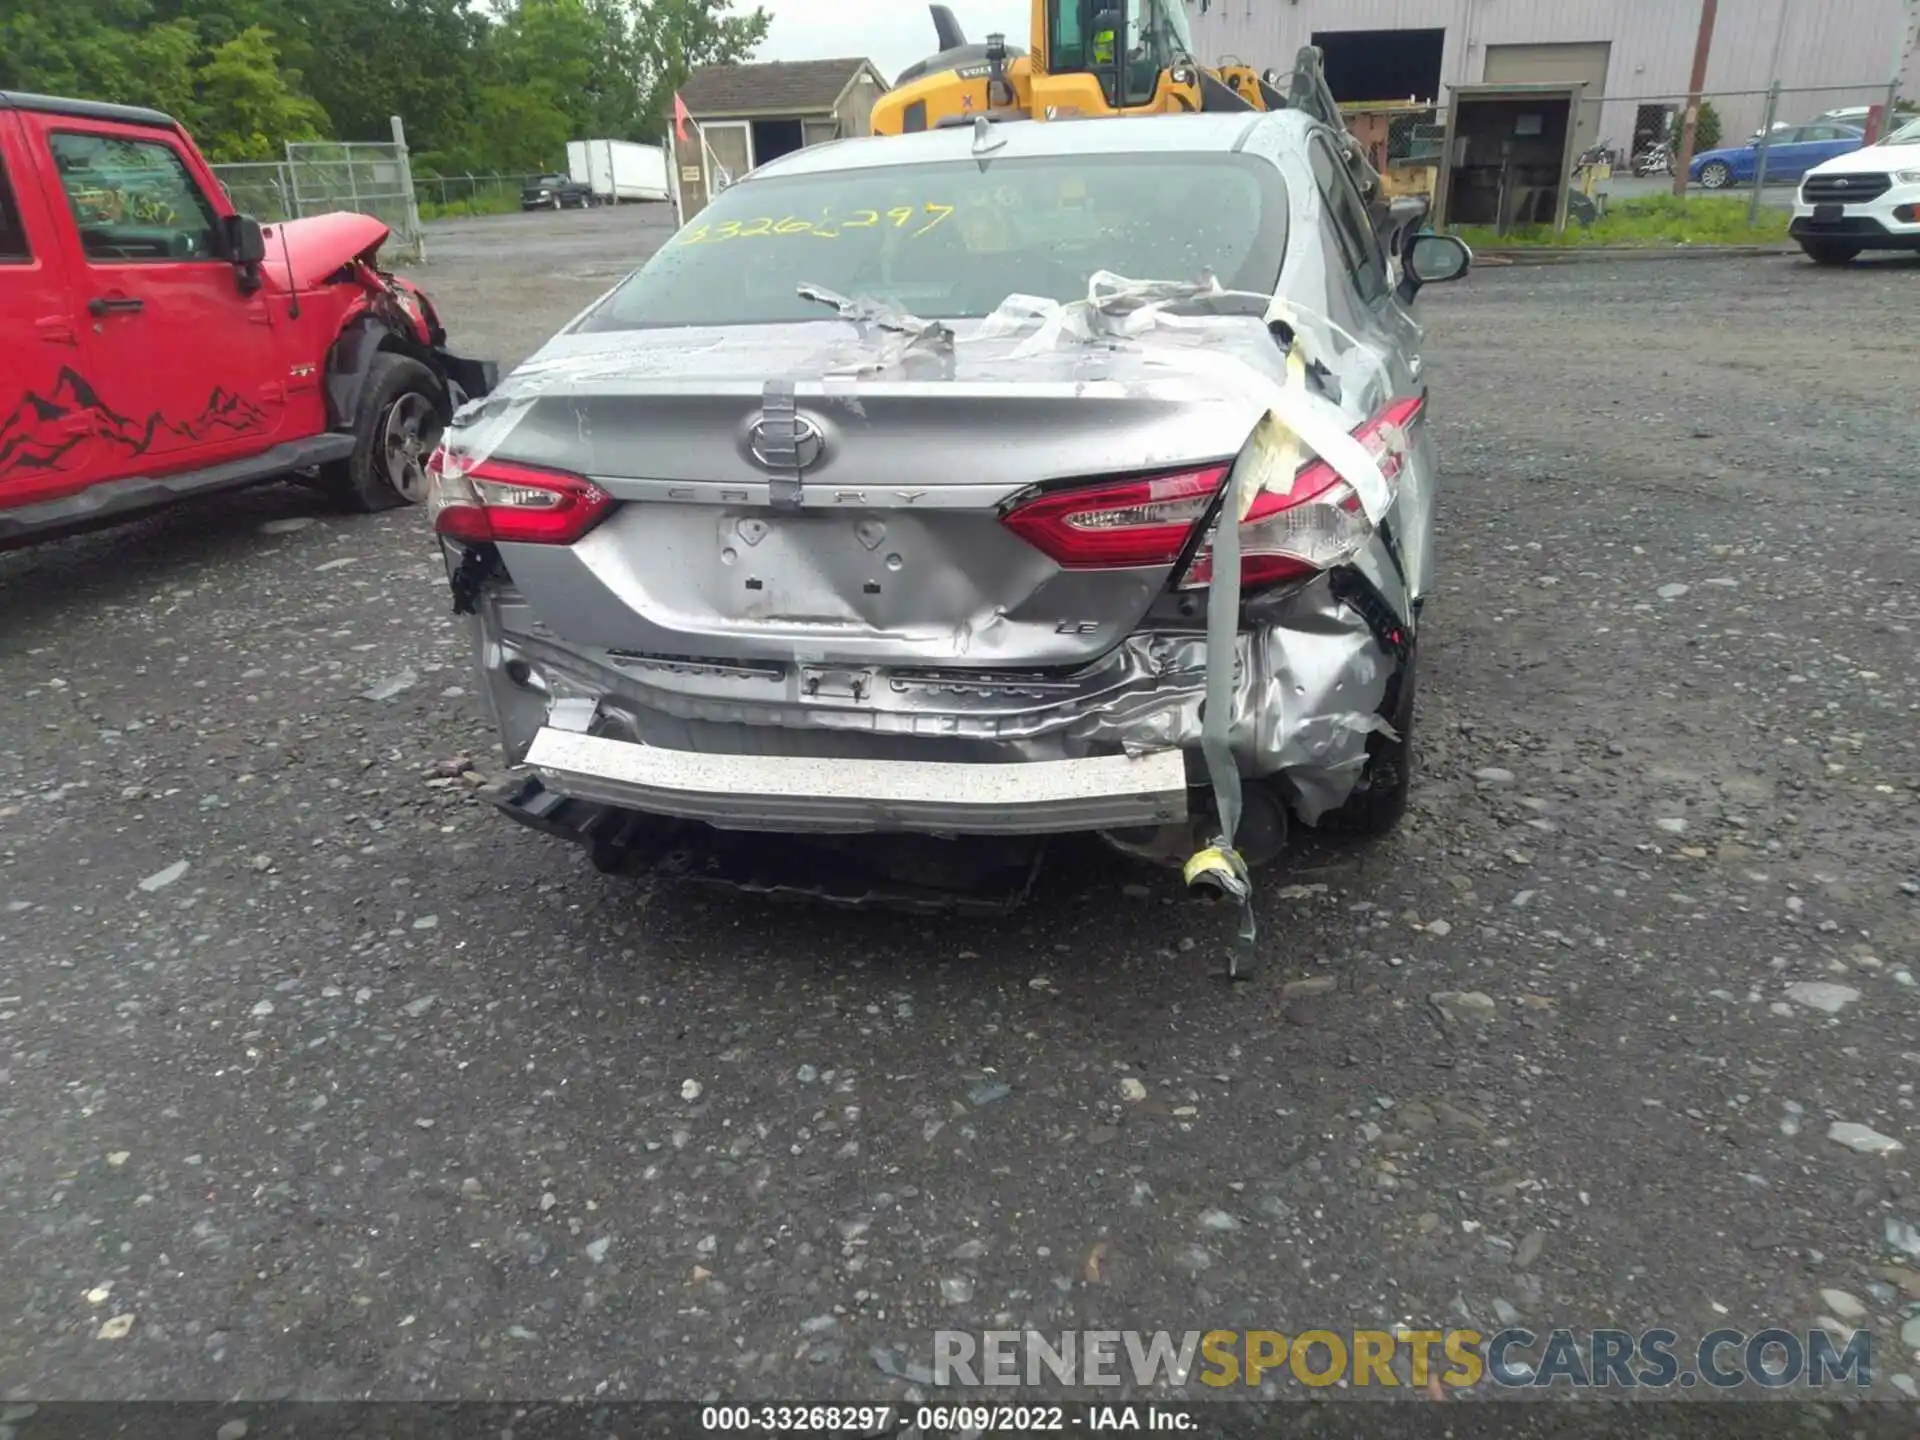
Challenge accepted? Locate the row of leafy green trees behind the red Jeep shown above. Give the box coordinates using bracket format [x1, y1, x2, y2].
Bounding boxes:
[0, 0, 768, 171]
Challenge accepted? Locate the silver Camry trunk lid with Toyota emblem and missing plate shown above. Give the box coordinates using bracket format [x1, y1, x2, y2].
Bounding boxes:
[449, 319, 1281, 668]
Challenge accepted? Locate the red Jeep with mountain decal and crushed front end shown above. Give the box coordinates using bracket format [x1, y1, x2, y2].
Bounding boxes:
[0, 90, 495, 549]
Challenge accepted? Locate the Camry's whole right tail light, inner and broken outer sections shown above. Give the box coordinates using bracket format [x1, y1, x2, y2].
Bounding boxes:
[1004, 399, 1421, 589]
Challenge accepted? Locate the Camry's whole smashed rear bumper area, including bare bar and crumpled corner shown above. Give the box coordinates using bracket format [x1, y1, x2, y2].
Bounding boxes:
[456, 564, 1404, 835]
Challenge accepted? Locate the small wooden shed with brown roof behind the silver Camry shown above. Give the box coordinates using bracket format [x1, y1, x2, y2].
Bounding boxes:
[668, 58, 887, 219]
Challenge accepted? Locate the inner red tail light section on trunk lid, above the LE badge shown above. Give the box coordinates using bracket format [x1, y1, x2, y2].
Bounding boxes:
[1004, 465, 1227, 570]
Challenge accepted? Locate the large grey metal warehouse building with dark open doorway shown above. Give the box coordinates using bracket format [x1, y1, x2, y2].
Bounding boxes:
[1187, 0, 1920, 150]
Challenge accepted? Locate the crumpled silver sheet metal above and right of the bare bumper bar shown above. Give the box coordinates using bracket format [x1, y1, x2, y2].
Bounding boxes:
[482, 580, 1392, 824]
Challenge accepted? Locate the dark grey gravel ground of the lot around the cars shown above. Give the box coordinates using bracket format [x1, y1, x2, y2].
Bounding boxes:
[0, 211, 1920, 1400]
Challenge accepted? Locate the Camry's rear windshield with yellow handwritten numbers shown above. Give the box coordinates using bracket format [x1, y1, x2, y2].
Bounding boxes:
[578, 152, 1286, 330]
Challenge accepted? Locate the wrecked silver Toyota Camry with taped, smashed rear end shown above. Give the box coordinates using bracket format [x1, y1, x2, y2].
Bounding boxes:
[430, 109, 1471, 960]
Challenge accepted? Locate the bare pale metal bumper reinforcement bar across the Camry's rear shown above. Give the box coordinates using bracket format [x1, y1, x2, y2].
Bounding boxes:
[526, 726, 1187, 835]
